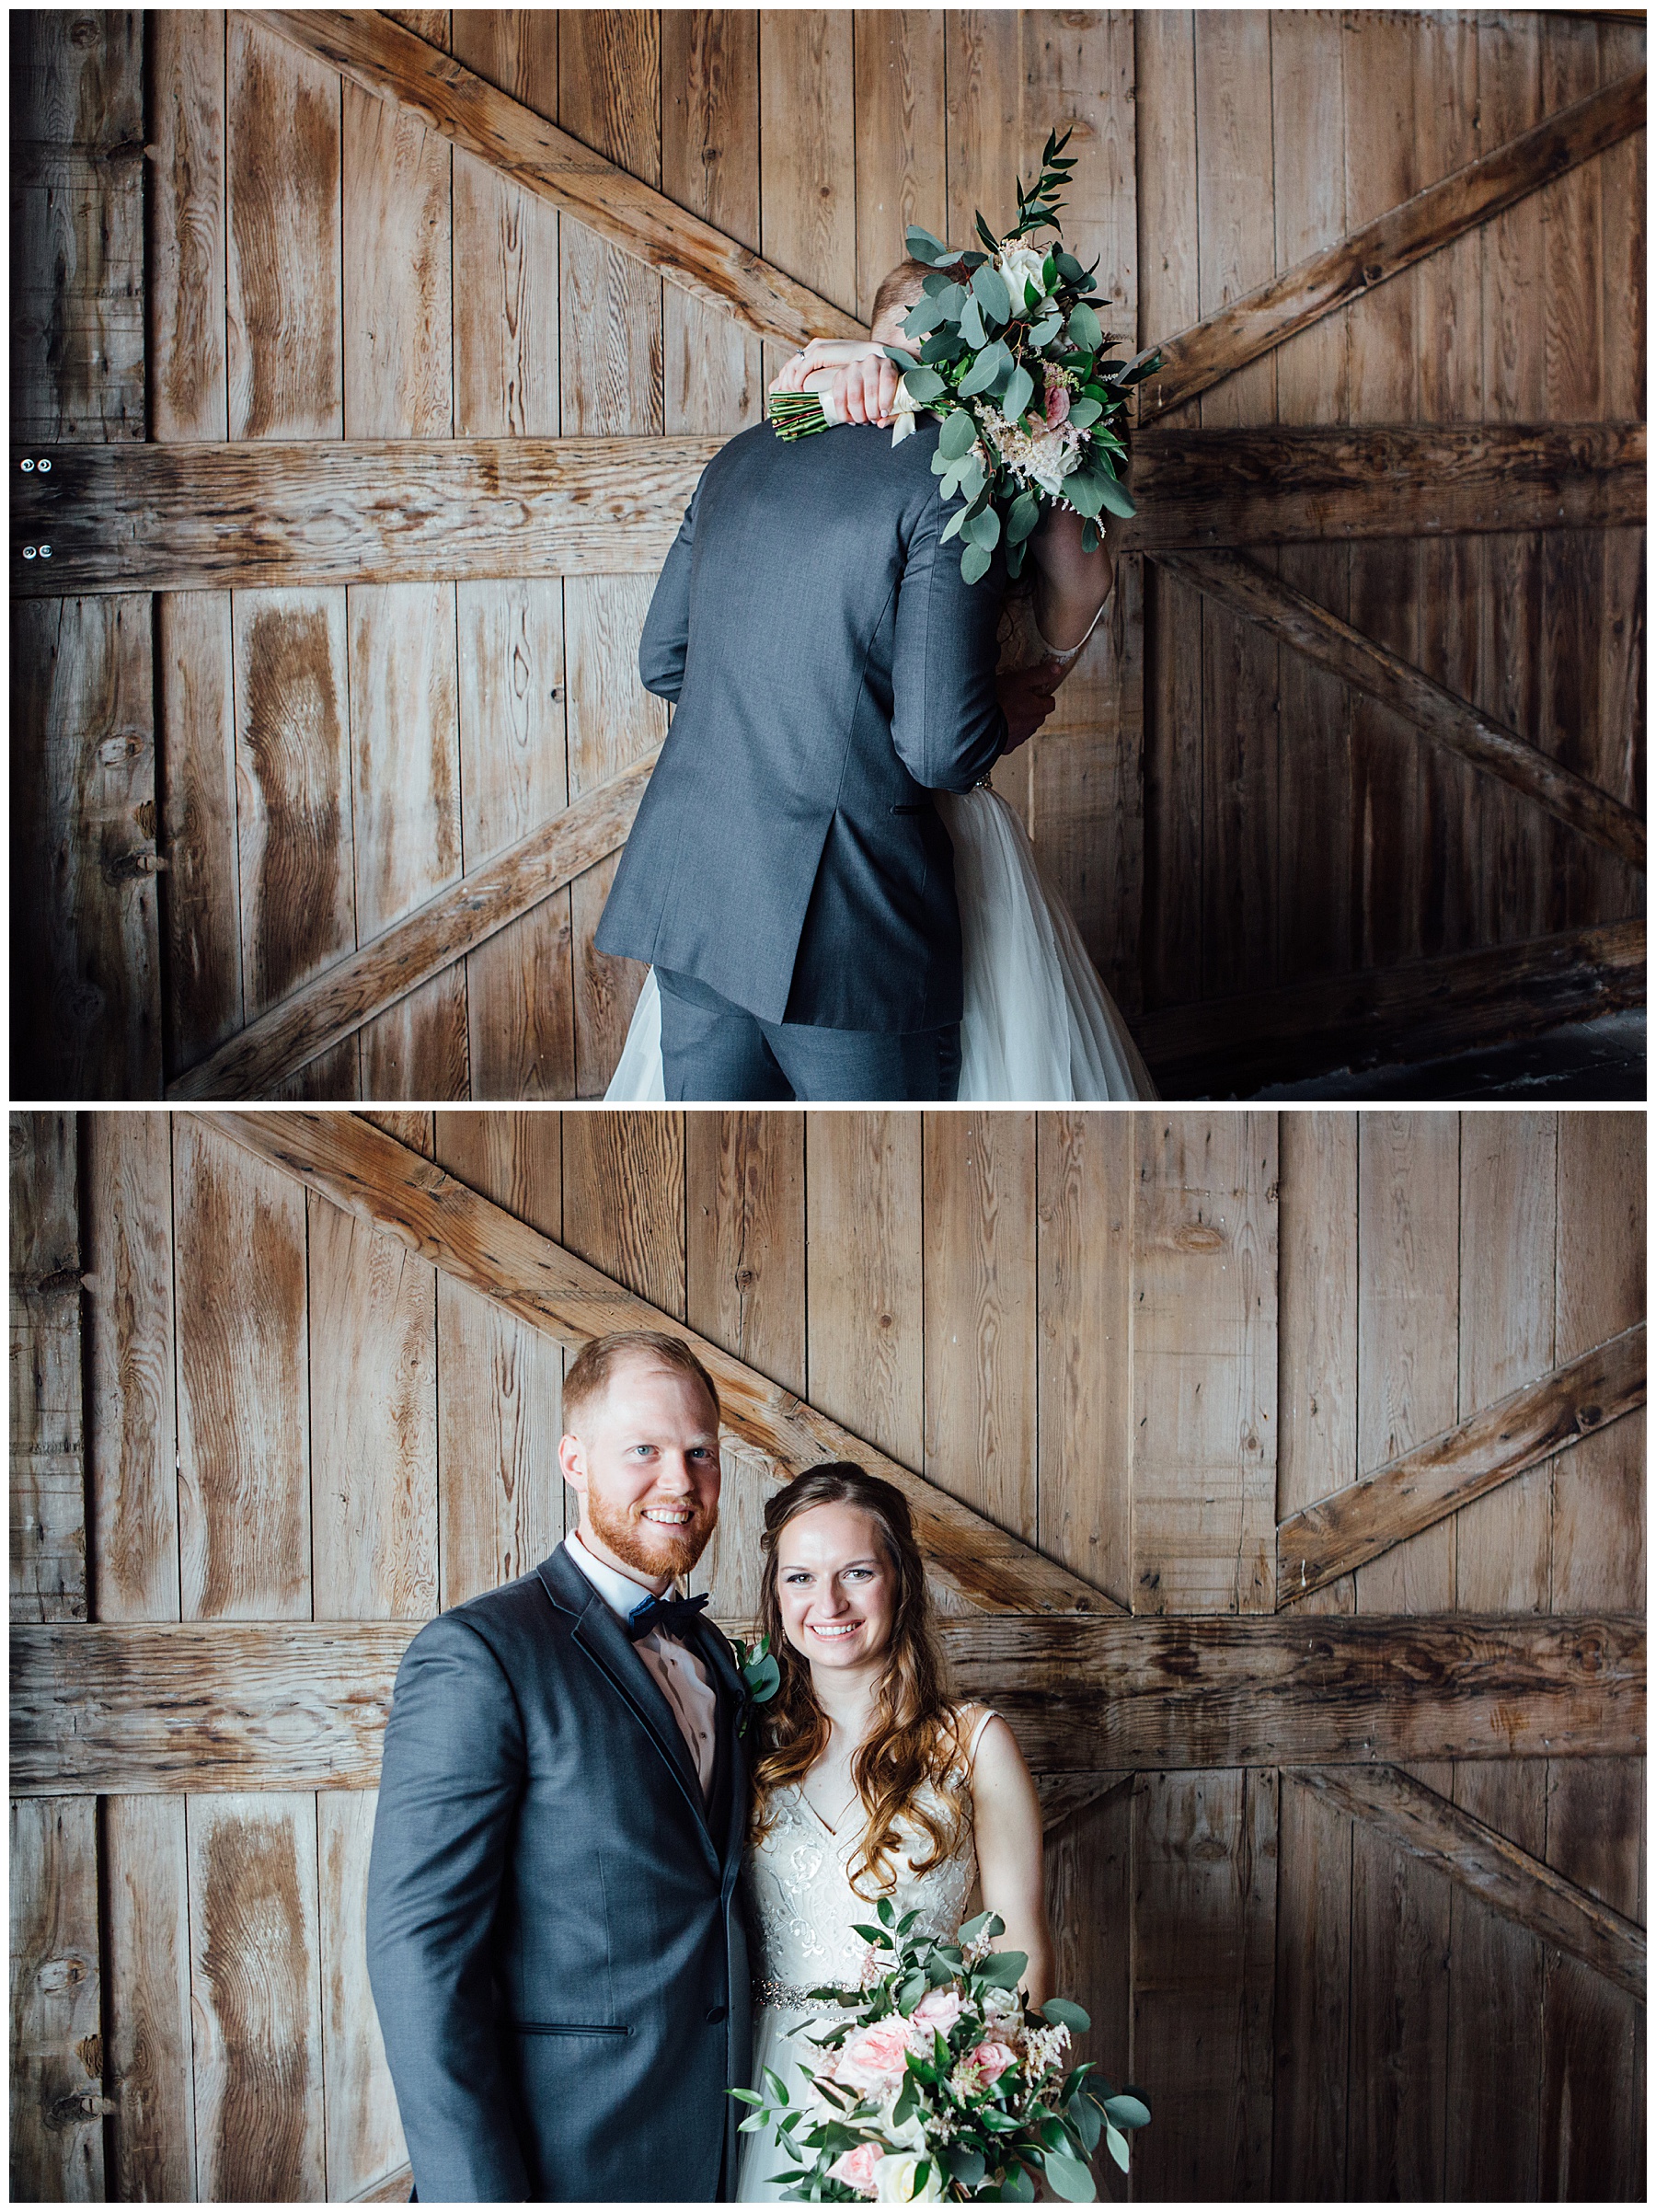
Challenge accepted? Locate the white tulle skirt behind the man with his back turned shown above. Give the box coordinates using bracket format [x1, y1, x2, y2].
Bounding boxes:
[604, 785, 1156, 1106]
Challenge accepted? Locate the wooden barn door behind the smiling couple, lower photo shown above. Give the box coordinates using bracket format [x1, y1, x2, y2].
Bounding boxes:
[11, 1112, 1645, 2201]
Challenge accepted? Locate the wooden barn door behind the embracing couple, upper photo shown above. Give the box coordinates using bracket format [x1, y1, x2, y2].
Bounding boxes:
[13, 9, 1645, 1100]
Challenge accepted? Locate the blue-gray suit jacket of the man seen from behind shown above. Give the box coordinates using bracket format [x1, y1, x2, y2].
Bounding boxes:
[597, 422, 1006, 1035]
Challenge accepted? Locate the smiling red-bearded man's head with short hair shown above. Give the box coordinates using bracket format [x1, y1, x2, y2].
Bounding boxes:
[558, 1360, 719, 1586]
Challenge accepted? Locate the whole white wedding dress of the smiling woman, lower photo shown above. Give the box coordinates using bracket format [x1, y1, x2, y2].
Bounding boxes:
[736, 1712, 993, 2206]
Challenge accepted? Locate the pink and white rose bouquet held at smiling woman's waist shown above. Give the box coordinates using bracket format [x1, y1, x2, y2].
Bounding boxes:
[731, 1898, 1150, 2203]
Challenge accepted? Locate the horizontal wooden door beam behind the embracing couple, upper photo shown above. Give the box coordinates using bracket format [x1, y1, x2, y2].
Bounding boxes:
[11, 422, 1645, 597]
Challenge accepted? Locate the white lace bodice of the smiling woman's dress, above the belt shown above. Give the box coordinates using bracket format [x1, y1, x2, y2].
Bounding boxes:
[745, 1712, 991, 2009]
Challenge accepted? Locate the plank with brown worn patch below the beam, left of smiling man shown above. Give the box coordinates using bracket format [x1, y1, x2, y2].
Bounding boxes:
[188, 1794, 328, 2203]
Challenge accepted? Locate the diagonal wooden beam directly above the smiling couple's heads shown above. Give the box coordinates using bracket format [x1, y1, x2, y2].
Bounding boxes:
[205, 1112, 1123, 1613]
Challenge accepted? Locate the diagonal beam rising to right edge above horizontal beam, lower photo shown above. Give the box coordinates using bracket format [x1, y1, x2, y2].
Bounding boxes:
[1276, 1320, 1645, 1606]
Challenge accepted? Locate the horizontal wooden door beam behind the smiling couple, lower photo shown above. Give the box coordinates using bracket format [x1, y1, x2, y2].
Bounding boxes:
[11, 1610, 1645, 1809]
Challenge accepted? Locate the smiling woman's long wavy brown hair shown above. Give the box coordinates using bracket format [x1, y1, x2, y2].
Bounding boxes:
[753, 1460, 966, 1895]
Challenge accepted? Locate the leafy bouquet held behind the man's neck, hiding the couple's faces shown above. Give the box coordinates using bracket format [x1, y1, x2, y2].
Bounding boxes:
[769, 131, 1161, 584]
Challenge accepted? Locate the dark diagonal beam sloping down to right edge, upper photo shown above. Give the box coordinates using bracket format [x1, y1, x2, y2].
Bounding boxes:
[1156, 553, 1645, 870]
